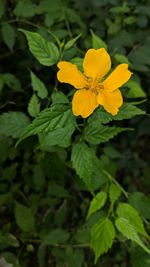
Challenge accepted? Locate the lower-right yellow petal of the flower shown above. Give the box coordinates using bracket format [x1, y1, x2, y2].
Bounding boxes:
[97, 89, 123, 115]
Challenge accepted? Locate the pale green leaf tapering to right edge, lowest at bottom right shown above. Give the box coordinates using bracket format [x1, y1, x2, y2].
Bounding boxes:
[115, 217, 150, 254]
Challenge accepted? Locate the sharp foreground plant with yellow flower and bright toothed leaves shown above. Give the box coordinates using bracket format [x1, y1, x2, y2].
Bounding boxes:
[15, 30, 150, 263]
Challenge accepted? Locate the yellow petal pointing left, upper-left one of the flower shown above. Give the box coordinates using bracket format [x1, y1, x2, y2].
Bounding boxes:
[57, 61, 86, 89]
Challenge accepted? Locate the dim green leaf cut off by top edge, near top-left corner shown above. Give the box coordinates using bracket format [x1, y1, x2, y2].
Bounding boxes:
[14, 0, 37, 18]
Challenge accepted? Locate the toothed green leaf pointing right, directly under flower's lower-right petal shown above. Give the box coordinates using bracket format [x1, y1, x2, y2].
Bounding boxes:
[88, 103, 145, 124]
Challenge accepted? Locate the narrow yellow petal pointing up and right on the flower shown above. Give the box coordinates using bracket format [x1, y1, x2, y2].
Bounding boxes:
[103, 64, 132, 91]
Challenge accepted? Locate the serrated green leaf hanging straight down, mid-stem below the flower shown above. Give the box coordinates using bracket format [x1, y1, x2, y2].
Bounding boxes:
[71, 143, 94, 185]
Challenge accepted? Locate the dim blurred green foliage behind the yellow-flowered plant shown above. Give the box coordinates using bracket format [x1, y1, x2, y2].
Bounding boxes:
[0, 0, 150, 267]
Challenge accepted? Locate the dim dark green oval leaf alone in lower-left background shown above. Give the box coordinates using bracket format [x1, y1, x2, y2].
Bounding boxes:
[15, 203, 34, 232]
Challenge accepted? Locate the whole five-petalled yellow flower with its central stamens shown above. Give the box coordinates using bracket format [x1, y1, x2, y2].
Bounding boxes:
[57, 48, 132, 118]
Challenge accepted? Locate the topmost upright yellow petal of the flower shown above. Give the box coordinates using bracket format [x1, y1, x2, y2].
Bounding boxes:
[83, 48, 111, 79]
